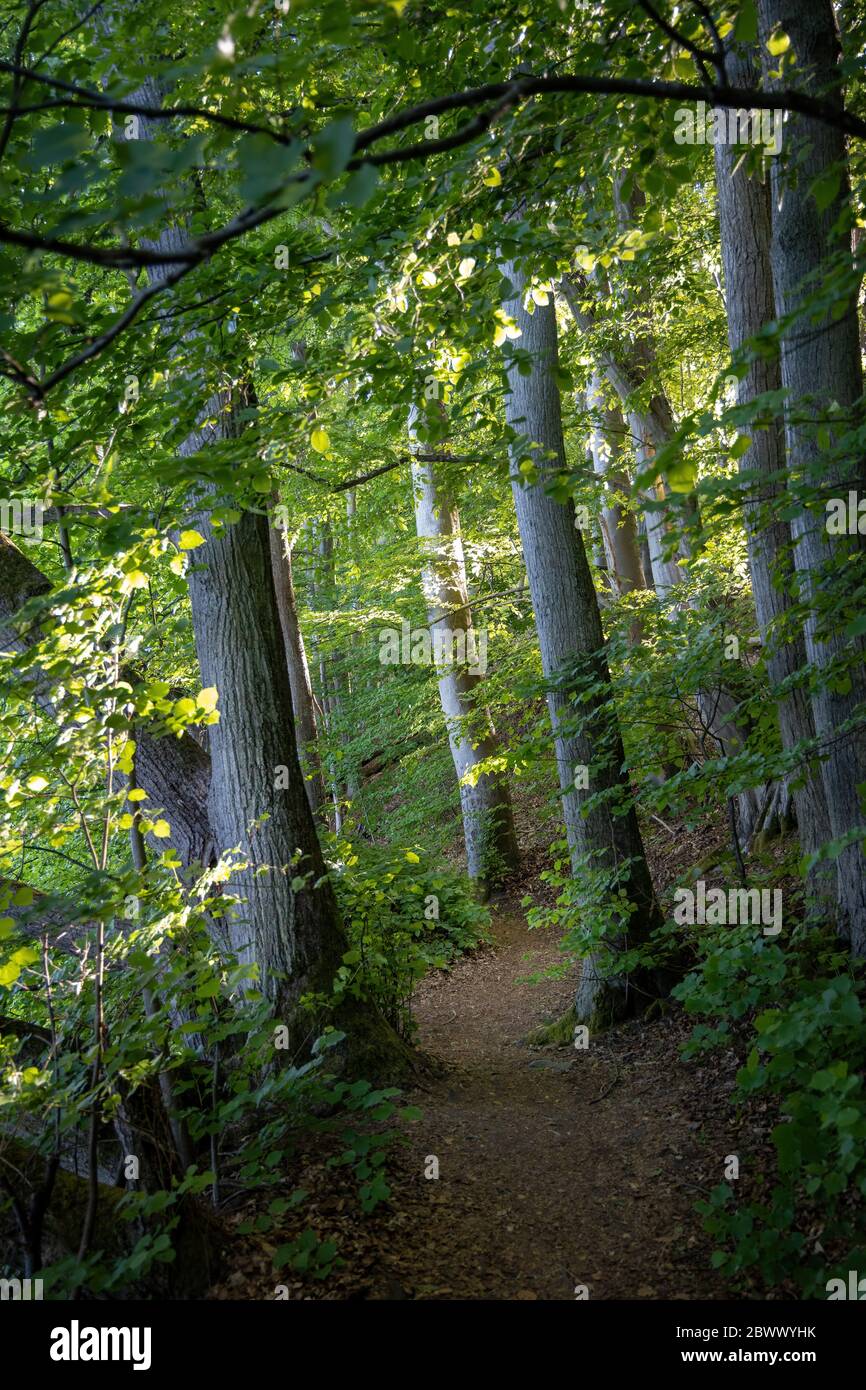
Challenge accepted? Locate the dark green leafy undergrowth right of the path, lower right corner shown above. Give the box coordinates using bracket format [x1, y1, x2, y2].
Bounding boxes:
[674, 926, 866, 1298]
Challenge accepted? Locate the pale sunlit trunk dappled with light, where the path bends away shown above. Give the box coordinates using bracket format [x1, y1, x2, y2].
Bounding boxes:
[409, 406, 518, 895]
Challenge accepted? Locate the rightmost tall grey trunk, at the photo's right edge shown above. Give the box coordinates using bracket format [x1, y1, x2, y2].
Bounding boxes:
[759, 0, 866, 955]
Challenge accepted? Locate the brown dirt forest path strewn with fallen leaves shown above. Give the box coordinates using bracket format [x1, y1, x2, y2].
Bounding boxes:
[366, 905, 726, 1300]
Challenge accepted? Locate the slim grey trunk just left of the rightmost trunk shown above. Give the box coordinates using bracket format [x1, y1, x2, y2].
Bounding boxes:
[716, 44, 830, 867]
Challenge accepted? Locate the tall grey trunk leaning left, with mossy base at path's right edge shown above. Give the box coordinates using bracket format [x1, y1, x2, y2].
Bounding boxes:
[503, 264, 662, 1026]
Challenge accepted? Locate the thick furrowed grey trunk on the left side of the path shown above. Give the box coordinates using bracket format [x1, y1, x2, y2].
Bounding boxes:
[177, 393, 346, 1022]
